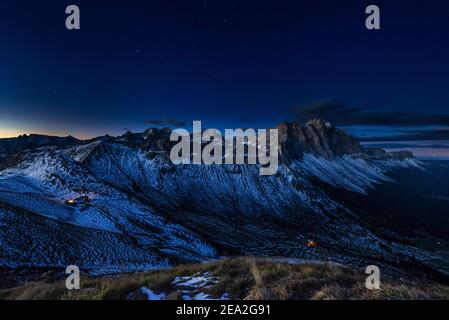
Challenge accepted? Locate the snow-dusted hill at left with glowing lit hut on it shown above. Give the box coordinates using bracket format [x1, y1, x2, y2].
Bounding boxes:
[0, 148, 216, 272]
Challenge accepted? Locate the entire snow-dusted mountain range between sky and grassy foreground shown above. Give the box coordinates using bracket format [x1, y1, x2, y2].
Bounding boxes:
[0, 120, 443, 282]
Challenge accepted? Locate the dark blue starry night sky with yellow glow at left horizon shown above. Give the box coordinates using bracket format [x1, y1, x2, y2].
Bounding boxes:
[0, 0, 449, 158]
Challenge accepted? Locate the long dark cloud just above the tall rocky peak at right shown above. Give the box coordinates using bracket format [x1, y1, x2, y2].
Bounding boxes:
[292, 101, 449, 128]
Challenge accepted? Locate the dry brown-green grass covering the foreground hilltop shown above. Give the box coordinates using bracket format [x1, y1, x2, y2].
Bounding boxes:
[0, 257, 449, 300]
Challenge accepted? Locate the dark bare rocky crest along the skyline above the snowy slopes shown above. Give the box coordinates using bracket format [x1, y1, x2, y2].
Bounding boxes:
[0, 119, 413, 163]
